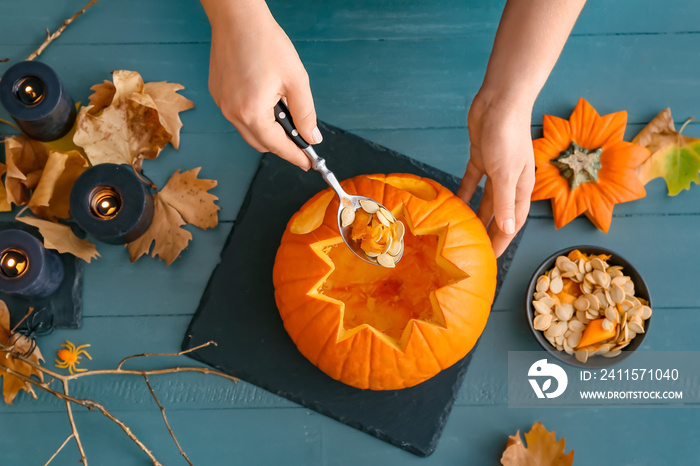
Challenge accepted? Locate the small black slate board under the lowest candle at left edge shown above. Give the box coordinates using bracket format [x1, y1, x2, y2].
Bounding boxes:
[0, 222, 84, 335]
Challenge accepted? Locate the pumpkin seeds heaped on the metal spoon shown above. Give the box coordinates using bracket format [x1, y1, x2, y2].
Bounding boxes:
[340, 199, 406, 268]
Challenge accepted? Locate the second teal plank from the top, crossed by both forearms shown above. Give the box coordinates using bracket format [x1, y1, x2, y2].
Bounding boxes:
[2, 34, 700, 132]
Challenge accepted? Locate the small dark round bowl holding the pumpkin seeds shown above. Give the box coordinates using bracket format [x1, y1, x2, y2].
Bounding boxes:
[525, 246, 653, 368]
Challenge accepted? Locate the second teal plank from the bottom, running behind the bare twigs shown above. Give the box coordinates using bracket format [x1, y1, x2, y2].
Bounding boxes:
[0, 300, 700, 416]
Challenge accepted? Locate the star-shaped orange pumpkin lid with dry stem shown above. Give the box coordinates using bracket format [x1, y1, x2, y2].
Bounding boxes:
[532, 99, 649, 233]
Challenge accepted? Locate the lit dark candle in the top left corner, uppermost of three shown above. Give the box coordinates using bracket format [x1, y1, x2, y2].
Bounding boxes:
[0, 61, 76, 141]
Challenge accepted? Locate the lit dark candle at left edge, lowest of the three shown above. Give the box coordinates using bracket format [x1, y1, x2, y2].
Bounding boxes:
[0, 230, 64, 298]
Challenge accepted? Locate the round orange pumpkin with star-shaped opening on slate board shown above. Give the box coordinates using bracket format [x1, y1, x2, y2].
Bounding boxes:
[273, 174, 496, 390]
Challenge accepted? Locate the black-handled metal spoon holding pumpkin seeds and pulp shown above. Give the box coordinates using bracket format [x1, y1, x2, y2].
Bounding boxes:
[275, 100, 405, 268]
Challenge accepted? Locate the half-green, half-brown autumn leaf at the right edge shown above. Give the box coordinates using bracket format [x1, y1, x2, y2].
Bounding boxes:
[632, 108, 700, 196]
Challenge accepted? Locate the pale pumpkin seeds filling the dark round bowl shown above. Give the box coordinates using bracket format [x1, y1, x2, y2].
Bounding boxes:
[532, 251, 651, 363]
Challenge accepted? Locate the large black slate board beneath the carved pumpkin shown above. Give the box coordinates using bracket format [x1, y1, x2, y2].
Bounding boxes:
[182, 123, 520, 456]
